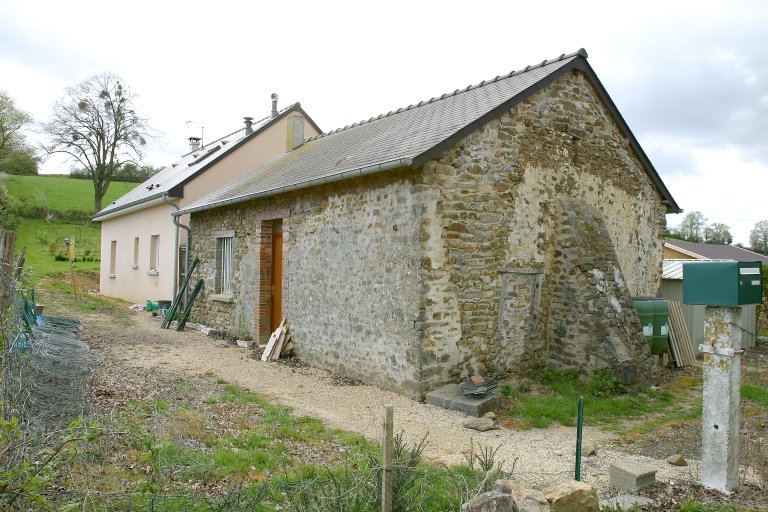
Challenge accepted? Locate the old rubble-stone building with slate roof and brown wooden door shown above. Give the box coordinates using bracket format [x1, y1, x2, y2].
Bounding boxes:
[179, 50, 680, 396]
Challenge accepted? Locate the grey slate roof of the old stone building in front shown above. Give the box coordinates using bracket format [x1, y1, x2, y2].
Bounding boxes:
[175, 49, 680, 215]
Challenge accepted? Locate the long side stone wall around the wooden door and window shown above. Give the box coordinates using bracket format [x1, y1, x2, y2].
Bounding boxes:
[192, 171, 423, 394]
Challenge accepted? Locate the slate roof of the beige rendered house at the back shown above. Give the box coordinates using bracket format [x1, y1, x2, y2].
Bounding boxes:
[92, 103, 321, 221]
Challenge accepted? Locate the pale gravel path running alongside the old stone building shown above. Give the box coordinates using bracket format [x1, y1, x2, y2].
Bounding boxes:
[84, 312, 698, 492]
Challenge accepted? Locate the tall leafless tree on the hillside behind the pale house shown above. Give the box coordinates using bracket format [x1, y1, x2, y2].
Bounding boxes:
[43, 73, 152, 211]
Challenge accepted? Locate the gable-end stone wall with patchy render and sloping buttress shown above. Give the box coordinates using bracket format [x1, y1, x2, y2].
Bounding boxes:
[414, 71, 665, 389]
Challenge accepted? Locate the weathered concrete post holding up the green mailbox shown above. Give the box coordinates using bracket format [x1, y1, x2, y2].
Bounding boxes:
[699, 306, 741, 492]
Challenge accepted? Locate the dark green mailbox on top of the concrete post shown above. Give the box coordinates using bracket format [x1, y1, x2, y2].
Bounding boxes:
[683, 261, 763, 307]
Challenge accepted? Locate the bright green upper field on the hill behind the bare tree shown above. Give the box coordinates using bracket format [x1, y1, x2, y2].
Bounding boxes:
[7, 175, 138, 215]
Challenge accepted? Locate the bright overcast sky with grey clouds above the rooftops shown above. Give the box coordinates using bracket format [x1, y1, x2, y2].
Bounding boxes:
[0, 0, 768, 244]
